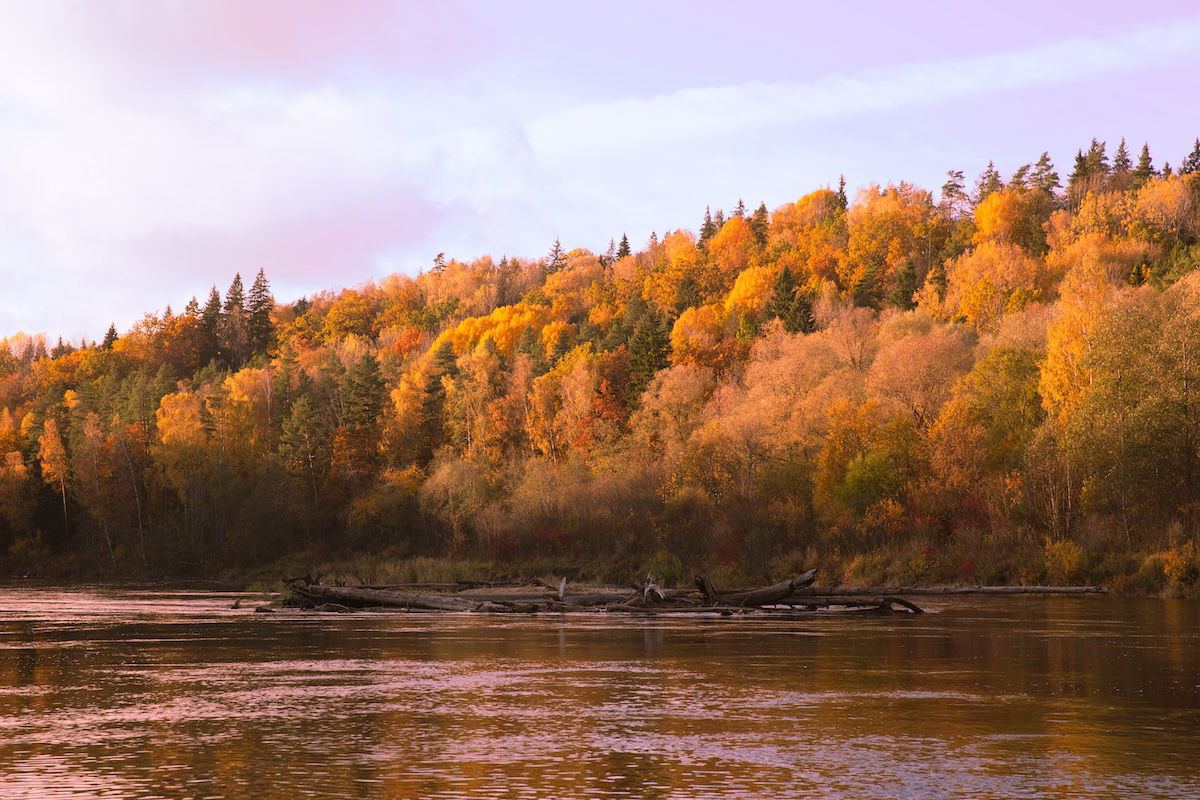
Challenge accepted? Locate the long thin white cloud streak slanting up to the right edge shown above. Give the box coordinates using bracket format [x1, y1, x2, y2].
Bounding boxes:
[528, 17, 1200, 158]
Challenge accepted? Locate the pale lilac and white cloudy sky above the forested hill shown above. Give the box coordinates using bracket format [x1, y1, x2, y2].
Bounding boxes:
[0, 0, 1200, 342]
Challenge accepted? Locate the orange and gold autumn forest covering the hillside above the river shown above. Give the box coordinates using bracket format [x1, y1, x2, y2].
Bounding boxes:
[0, 140, 1200, 593]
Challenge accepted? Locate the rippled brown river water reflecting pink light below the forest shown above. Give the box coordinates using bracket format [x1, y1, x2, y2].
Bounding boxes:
[0, 588, 1200, 800]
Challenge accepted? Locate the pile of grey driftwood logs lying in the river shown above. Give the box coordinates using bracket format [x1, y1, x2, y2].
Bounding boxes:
[284, 570, 923, 615]
